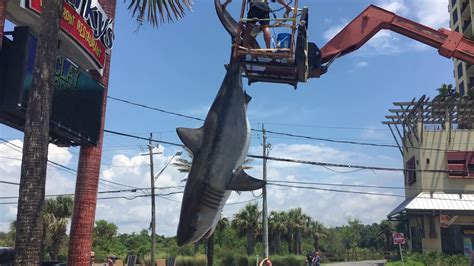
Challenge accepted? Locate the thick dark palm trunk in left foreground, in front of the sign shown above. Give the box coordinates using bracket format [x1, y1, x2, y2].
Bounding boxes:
[15, 0, 64, 265]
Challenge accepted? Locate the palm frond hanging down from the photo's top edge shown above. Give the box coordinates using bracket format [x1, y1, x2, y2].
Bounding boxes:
[124, 0, 192, 27]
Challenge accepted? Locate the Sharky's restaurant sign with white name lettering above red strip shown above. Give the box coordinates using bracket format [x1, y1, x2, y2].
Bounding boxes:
[25, 0, 115, 68]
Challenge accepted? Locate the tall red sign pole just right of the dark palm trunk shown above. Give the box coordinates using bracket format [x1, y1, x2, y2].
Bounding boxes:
[67, 0, 116, 265]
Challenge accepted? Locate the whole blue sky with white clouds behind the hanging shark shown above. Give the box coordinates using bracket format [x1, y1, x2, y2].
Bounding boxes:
[0, 0, 453, 235]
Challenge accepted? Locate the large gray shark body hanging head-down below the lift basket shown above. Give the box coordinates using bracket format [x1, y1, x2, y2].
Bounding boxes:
[176, 64, 265, 246]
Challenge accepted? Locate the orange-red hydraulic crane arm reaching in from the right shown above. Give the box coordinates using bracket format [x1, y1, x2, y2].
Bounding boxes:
[309, 5, 474, 77]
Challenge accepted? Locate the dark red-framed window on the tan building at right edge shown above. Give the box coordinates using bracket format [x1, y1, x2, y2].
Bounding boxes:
[446, 152, 474, 178]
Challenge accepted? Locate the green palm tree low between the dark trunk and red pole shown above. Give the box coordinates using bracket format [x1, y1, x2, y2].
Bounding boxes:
[43, 196, 73, 261]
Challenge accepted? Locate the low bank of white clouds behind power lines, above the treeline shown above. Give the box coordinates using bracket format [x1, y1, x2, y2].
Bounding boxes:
[0, 141, 403, 236]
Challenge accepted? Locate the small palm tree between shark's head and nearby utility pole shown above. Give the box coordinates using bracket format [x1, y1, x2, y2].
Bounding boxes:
[232, 203, 262, 256]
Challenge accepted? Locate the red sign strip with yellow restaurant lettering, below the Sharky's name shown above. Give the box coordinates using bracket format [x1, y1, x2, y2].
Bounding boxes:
[27, 0, 107, 68]
